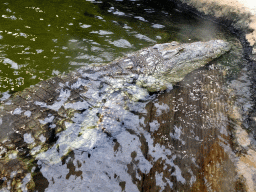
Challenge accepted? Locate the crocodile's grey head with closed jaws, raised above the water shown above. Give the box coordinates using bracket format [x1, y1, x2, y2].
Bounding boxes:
[137, 40, 231, 92]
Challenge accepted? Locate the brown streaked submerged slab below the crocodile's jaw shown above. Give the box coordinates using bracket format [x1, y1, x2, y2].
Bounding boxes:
[132, 66, 238, 192]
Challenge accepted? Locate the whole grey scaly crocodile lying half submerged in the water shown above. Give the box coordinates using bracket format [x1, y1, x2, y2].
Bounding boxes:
[0, 40, 231, 191]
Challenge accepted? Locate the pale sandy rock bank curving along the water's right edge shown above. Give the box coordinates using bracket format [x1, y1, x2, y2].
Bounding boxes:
[170, 0, 256, 191]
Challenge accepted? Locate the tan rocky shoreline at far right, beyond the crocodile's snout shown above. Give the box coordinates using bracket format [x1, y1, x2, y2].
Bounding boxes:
[167, 0, 256, 191]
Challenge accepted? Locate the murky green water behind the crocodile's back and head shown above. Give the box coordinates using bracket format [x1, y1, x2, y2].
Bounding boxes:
[0, 0, 232, 95]
